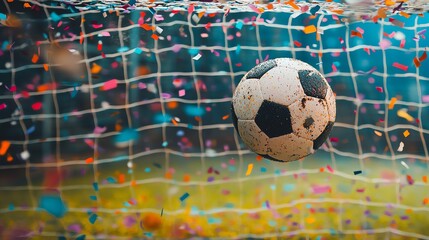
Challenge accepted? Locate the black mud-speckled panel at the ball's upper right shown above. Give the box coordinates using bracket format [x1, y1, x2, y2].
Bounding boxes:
[298, 70, 329, 99]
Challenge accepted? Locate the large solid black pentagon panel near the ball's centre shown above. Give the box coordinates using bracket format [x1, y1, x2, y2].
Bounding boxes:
[255, 100, 292, 138]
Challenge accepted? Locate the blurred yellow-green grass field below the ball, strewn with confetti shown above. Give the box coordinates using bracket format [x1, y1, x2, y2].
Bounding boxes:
[0, 153, 429, 239]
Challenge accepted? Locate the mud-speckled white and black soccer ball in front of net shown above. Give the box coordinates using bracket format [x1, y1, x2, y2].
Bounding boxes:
[231, 58, 336, 162]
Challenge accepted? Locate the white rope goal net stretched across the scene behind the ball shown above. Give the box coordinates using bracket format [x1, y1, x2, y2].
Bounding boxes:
[0, 0, 429, 239]
